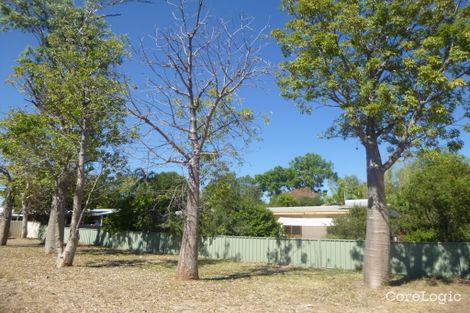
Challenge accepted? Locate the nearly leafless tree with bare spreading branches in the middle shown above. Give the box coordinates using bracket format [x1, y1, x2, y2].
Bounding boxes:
[129, 0, 267, 280]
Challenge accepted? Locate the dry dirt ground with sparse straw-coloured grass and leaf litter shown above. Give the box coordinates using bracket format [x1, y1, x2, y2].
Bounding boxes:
[0, 239, 470, 313]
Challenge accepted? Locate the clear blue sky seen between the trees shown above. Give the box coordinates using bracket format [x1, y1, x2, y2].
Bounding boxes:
[0, 0, 470, 180]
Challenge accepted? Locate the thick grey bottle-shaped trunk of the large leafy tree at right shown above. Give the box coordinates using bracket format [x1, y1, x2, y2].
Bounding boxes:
[364, 144, 390, 289]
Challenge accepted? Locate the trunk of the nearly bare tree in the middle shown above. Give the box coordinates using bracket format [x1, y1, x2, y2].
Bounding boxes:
[176, 159, 200, 280]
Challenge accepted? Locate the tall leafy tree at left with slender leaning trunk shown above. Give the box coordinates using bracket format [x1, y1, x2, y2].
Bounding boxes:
[2, 1, 129, 267]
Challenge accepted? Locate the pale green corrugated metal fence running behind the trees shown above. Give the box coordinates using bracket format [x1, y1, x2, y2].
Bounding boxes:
[39, 225, 470, 277]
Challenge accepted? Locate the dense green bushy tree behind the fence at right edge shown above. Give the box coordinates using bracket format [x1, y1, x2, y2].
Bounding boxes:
[393, 153, 470, 241]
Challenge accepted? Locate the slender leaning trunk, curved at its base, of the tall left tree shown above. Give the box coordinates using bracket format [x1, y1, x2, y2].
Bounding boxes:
[57, 118, 88, 268]
